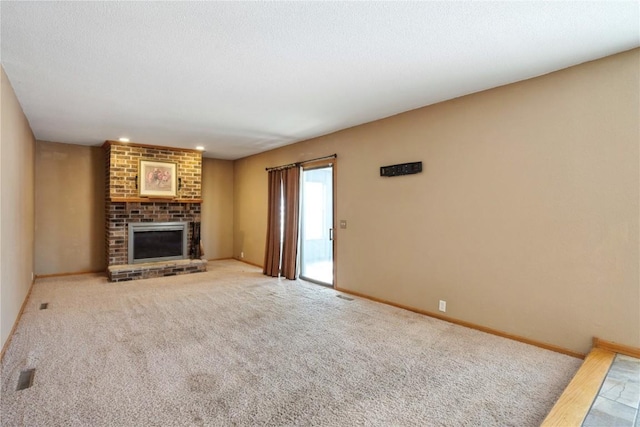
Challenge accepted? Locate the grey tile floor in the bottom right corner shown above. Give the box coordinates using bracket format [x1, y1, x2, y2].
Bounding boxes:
[582, 354, 640, 427]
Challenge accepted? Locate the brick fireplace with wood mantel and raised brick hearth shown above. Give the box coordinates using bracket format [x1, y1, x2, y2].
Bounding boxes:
[103, 141, 207, 282]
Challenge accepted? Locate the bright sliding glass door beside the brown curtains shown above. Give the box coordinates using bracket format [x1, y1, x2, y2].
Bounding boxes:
[300, 165, 333, 286]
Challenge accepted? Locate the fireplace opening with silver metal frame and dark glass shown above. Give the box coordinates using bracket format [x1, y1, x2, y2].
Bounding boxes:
[128, 222, 188, 264]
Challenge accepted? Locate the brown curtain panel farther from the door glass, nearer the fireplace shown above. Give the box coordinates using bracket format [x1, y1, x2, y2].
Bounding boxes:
[262, 170, 283, 277]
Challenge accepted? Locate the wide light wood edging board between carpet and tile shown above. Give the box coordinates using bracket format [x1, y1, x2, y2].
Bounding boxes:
[542, 348, 615, 427]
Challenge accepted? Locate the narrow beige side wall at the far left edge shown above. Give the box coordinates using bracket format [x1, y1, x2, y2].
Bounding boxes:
[0, 68, 35, 346]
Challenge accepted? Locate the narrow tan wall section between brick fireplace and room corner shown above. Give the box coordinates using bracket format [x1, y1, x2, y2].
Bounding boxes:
[201, 158, 233, 259]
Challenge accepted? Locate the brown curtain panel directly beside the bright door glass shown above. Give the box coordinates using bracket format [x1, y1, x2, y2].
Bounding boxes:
[282, 167, 300, 280]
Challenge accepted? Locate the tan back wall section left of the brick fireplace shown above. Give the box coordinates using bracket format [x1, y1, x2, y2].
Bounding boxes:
[35, 141, 106, 275]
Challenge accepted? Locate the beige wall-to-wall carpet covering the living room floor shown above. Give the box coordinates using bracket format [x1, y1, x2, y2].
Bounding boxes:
[1, 261, 581, 426]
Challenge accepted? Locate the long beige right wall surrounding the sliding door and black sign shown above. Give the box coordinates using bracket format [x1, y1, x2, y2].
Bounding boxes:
[234, 49, 640, 353]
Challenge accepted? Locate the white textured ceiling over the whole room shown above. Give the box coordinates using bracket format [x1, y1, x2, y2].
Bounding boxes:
[0, 1, 640, 159]
